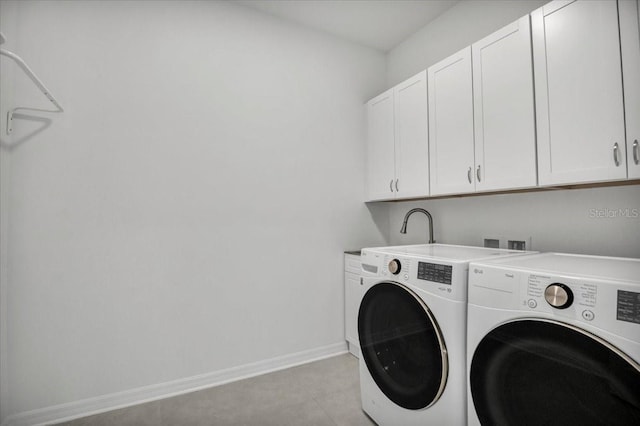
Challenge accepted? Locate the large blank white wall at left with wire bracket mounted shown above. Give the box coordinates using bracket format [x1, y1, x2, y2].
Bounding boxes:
[0, 1, 388, 418]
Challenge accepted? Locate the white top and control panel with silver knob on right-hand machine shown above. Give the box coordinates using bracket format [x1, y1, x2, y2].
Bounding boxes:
[468, 253, 640, 341]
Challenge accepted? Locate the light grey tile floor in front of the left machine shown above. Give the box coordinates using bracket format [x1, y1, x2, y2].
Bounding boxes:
[56, 354, 375, 426]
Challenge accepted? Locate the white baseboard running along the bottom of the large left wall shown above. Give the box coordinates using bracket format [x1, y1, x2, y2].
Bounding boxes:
[1, 342, 347, 426]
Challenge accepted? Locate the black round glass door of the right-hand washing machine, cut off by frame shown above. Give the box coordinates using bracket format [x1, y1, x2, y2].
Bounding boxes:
[470, 320, 640, 426]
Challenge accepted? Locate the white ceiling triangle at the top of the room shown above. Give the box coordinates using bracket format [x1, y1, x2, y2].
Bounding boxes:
[234, 0, 457, 52]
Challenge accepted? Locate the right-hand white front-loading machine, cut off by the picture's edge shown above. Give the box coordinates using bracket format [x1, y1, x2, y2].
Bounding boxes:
[467, 253, 640, 426]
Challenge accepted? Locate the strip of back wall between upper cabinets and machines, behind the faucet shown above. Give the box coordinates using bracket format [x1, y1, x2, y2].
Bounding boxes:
[390, 185, 640, 258]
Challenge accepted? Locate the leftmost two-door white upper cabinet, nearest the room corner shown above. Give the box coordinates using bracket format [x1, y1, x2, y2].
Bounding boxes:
[367, 71, 429, 201]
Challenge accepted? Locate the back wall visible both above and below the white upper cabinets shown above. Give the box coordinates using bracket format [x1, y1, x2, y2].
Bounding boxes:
[387, 0, 640, 257]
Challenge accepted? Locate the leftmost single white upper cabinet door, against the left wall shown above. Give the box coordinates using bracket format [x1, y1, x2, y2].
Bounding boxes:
[367, 89, 395, 201]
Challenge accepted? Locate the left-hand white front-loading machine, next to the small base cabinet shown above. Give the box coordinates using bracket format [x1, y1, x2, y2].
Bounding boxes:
[358, 244, 523, 426]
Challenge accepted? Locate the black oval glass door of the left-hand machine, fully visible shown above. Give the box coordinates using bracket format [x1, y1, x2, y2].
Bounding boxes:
[358, 282, 448, 410]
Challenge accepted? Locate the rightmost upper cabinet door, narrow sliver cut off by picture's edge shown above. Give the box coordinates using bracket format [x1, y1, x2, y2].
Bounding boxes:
[619, 0, 640, 179]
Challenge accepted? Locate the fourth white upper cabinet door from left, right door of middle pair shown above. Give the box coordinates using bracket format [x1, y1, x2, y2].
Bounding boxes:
[472, 16, 537, 191]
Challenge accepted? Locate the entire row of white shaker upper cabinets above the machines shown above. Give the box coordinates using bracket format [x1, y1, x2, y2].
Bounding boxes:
[367, 0, 640, 201]
